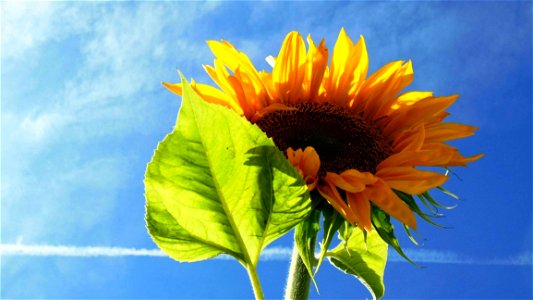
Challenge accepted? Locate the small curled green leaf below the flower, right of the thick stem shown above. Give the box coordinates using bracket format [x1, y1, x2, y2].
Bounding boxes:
[327, 229, 388, 299]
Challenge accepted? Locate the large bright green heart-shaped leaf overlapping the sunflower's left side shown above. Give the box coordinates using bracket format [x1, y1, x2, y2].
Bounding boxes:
[145, 80, 311, 268]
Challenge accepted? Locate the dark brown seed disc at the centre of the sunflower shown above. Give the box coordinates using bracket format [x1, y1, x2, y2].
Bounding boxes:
[256, 103, 392, 177]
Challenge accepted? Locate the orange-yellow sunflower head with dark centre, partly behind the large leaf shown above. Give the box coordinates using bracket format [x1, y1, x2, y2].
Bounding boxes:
[163, 29, 482, 230]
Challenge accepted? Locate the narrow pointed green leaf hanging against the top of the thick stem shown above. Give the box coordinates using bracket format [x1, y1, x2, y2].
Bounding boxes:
[294, 210, 320, 278]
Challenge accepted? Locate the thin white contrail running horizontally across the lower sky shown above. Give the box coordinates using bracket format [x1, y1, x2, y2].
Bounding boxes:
[0, 243, 533, 266]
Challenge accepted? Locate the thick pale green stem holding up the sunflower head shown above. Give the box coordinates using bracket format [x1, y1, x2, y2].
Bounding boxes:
[285, 236, 316, 300]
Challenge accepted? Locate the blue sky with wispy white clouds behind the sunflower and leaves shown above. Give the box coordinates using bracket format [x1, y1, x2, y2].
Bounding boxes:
[0, 1, 533, 299]
